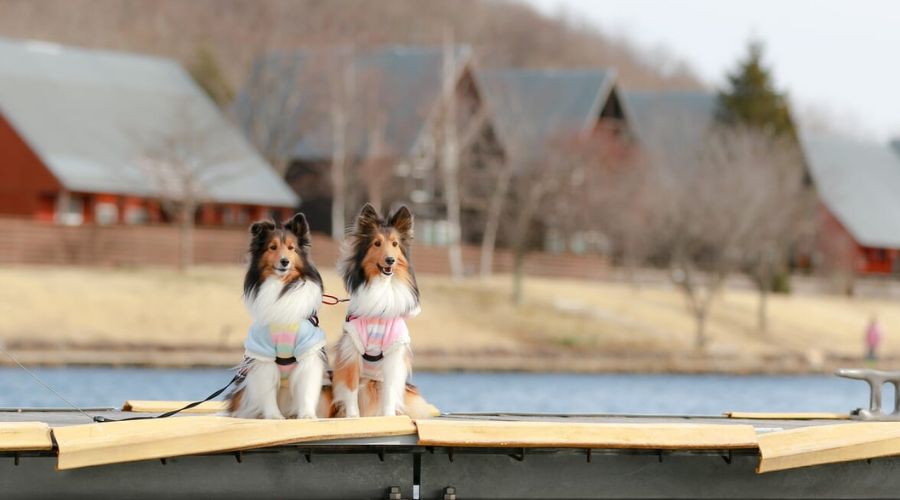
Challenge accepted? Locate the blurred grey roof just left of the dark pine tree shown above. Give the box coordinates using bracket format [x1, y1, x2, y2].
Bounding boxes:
[623, 91, 718, 154]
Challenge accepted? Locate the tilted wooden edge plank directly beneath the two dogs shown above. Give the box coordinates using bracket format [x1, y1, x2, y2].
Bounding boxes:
[53, 416, 416, 470]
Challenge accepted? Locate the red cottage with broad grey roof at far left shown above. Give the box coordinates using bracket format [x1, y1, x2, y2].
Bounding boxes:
[0, 40, 298, 225]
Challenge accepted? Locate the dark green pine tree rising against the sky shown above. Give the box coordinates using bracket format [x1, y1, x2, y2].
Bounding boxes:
[718, 42, 796, 138]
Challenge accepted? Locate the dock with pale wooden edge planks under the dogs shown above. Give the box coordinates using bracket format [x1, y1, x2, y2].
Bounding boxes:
[0, 402, 900, 499]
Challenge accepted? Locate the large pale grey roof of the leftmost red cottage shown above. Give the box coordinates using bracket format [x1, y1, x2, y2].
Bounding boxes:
[0, 39, 298, 206]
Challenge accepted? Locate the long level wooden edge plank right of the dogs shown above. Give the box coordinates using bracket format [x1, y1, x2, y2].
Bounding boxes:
[416, 418, 756, 450]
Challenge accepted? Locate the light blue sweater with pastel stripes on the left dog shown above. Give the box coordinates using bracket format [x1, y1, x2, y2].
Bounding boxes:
[244, 317, 325, 386]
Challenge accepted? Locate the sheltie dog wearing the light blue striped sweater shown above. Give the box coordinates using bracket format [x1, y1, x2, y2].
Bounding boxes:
[229, 213, 327, 419]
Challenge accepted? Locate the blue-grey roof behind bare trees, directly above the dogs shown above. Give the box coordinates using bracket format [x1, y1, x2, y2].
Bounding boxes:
[235, 46, 471, 160]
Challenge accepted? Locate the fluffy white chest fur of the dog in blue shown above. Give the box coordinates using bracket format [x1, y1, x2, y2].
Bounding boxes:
[244, 277, 322, 324]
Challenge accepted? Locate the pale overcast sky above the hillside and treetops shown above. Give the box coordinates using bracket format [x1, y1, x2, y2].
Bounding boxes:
[522, 0, 900, 141]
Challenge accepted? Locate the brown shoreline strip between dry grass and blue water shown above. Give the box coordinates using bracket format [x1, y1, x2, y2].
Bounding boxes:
[0, 344, 888, 375]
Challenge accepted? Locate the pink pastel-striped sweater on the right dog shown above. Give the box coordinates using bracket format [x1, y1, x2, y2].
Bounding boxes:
[344, 316, 410, 382]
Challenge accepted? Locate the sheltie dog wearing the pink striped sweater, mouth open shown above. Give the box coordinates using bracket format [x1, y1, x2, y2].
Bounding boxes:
[329, 204, 436, 417]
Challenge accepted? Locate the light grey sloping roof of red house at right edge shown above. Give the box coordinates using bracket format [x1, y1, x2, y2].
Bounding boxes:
[800, 133, 900, 248]
